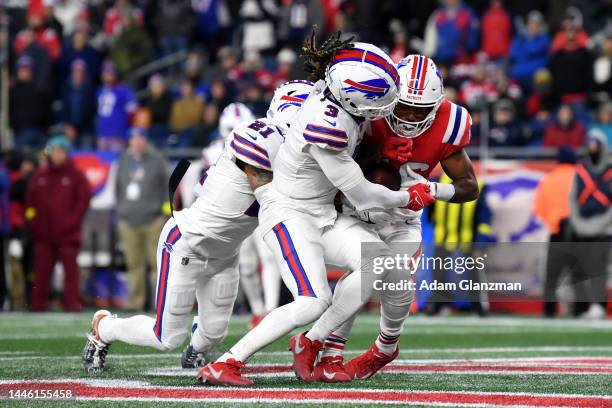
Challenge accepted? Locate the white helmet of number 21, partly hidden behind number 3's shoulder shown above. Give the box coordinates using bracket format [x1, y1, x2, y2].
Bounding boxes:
[266, 81, 314, 133]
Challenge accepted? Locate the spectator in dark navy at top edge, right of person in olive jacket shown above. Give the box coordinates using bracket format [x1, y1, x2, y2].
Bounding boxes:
[154, 0, 193, 55]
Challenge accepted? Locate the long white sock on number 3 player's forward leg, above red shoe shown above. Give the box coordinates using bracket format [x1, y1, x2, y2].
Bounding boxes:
[227, 296, 328, 361]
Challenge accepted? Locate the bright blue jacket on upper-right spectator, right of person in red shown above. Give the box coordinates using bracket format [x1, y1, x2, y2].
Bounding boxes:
[510, 33, 550, 85]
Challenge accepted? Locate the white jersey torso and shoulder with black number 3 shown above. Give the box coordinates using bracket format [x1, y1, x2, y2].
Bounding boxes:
[262, 83, 361, 228]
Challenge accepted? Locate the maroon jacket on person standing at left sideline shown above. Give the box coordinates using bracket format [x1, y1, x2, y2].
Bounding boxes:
[26, 159, 91, 244]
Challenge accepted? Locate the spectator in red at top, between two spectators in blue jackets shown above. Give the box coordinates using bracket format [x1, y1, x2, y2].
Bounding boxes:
[482, 0, 512, 60]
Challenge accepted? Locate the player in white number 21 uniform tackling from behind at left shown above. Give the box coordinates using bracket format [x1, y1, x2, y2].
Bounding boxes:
[83, 83, 312, 372]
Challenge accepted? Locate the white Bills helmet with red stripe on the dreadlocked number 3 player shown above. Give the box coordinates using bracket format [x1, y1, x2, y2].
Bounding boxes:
[325, 42, 400, 120]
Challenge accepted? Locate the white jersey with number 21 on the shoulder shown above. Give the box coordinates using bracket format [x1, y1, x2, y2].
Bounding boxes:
[174, 119, 283, 258]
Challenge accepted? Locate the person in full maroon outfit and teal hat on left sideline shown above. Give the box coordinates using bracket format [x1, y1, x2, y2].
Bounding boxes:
[26, 136, 91, 312]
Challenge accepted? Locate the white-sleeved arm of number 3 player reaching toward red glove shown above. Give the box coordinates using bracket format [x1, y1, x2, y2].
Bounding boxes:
[310, 145, 409, 211]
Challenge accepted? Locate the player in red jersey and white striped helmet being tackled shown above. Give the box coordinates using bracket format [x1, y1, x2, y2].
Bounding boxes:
[315, 55, 479, 382]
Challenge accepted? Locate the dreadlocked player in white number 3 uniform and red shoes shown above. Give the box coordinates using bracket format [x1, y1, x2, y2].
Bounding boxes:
[197, 34, 429, 385]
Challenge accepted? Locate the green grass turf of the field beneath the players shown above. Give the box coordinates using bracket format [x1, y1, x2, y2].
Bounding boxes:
[0, 313, 612, 407]
